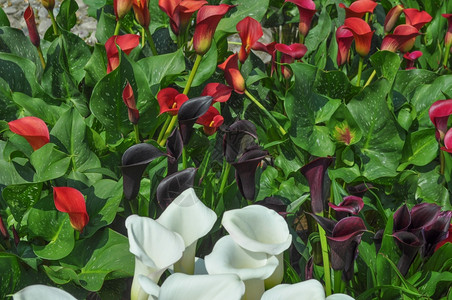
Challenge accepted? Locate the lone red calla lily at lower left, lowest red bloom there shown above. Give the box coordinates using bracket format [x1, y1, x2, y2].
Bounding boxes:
[53, 187, 89, 232]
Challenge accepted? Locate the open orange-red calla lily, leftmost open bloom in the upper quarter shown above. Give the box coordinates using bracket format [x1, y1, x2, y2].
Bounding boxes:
[105, 34, 140, 73]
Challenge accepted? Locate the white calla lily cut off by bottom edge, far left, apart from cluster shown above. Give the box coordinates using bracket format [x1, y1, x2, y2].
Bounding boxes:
[13, 284, 77, 300]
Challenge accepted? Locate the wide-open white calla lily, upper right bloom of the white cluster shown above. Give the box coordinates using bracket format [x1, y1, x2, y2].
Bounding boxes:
[221, 205, 292, 288]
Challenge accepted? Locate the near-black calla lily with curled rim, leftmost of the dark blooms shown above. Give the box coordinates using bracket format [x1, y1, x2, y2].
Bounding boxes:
[121, 143, 165, 200]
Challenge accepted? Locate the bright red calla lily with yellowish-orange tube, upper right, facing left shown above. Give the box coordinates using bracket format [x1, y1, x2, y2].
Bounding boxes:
[344, 18, 374, 57]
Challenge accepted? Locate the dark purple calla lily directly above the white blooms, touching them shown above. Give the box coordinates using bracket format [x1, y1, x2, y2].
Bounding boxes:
[157, 168, 197, 209]
